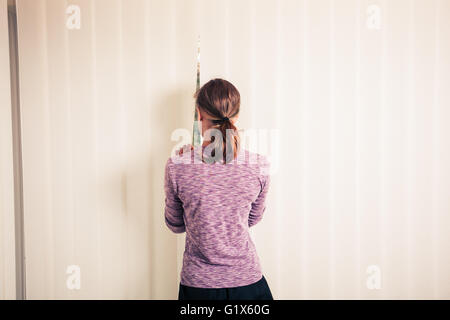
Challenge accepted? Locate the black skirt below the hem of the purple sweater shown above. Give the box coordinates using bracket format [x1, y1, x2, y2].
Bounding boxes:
[178, 276, 273, 300]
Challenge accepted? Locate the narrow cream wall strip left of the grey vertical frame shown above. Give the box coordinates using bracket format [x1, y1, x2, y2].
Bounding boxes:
[0, 0, 16, 300]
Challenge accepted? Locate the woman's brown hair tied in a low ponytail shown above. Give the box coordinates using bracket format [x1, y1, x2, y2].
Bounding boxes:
[194, 78, 241, 163]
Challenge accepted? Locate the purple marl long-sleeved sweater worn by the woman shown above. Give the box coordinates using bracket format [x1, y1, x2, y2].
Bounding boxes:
[164, 147, 270, 288]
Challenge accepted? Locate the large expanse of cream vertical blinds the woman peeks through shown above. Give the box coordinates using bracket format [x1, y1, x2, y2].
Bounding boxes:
[13, 0, 450, 299]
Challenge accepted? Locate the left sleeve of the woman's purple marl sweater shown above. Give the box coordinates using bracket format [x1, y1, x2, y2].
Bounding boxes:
[164, 158, 186, 233]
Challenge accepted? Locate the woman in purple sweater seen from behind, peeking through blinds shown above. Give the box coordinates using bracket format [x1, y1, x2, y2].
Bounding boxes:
[165, 79, 273, 300]
